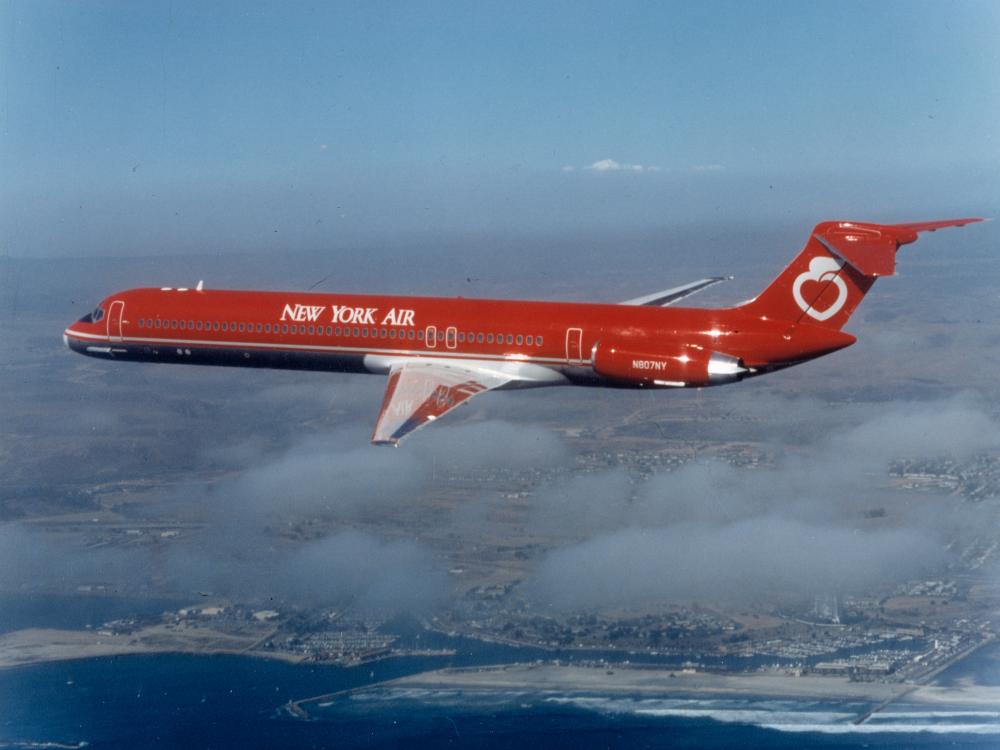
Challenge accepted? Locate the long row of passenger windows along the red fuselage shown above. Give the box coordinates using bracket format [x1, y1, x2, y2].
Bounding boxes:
[139, 318, 542, 346]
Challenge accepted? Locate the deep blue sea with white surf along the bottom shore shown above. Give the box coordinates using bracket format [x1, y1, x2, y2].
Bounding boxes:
[0, 605, 1000, 750]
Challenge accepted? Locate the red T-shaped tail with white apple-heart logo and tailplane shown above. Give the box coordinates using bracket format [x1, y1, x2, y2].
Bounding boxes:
[740, 218, 982, 330]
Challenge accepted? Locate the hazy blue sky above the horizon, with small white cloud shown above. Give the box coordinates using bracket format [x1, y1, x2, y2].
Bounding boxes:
[0, 2, 1000, 257]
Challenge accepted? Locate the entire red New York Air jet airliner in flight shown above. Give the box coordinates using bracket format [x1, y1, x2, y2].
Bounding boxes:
[63, 218, 982, 445]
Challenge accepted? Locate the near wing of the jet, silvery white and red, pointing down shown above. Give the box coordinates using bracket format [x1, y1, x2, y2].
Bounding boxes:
[372, 362, 516, 445]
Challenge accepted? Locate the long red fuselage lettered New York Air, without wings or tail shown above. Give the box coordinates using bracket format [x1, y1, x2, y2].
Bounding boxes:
[65, 289, 854, 387]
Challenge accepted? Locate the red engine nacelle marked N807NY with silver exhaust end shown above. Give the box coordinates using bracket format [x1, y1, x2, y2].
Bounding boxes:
[594, 343, 747, 388]
